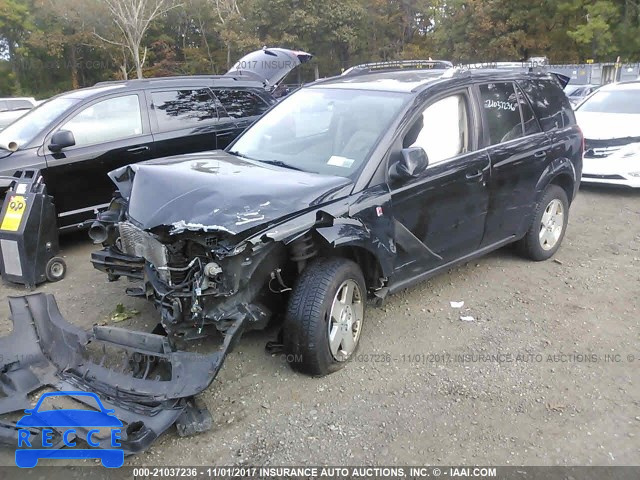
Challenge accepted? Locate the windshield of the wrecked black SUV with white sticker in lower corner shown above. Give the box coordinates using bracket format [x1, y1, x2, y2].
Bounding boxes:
[229, 88, 409, 178]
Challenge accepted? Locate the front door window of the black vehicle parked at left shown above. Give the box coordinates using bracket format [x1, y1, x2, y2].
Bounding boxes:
[60, 95, 142, 146]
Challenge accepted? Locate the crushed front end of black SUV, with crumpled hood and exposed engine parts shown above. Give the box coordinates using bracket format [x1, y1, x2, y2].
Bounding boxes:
[92, 152, 394, 342]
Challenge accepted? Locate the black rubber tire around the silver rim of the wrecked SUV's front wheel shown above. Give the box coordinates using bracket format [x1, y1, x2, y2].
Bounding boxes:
[283, 258, 366, 376]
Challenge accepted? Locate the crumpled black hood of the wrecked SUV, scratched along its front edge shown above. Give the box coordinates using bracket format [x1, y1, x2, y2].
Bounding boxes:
[109, 150, 352, 235]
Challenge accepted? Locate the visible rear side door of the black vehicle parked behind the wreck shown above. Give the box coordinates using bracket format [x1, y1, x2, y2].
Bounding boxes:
[146, 86, 228, 158]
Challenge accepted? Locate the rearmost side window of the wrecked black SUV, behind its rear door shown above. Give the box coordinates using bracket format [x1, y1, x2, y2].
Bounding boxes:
[518, 79, 576, 132]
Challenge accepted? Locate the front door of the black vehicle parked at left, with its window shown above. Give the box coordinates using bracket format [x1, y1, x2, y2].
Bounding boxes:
[43, 91, 153, 227]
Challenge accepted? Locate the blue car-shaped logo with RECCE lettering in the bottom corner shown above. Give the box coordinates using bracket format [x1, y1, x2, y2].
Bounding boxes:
[15, 391, 124, 468]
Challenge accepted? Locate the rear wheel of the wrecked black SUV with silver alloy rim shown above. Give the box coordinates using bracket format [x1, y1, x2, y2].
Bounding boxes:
[520, 185, 569, 261]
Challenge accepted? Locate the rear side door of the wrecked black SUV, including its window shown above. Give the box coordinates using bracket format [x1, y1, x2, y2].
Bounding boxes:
[477, 81, 551, 246]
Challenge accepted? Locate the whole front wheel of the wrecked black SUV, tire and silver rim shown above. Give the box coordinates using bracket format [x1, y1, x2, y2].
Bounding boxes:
[283, 258, 366, 376]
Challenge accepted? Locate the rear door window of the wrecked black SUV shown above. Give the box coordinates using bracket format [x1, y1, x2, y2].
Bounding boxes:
[480, 82, 523, 145]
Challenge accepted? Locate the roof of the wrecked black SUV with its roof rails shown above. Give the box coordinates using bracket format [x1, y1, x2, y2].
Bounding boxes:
[313, 68, 564, 93]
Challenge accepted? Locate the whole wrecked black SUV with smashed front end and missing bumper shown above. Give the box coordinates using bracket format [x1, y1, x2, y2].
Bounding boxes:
[91, 68, 583, 375]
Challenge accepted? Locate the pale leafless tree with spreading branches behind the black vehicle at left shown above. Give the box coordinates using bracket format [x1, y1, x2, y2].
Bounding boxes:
[95, 0, 179, 78]
